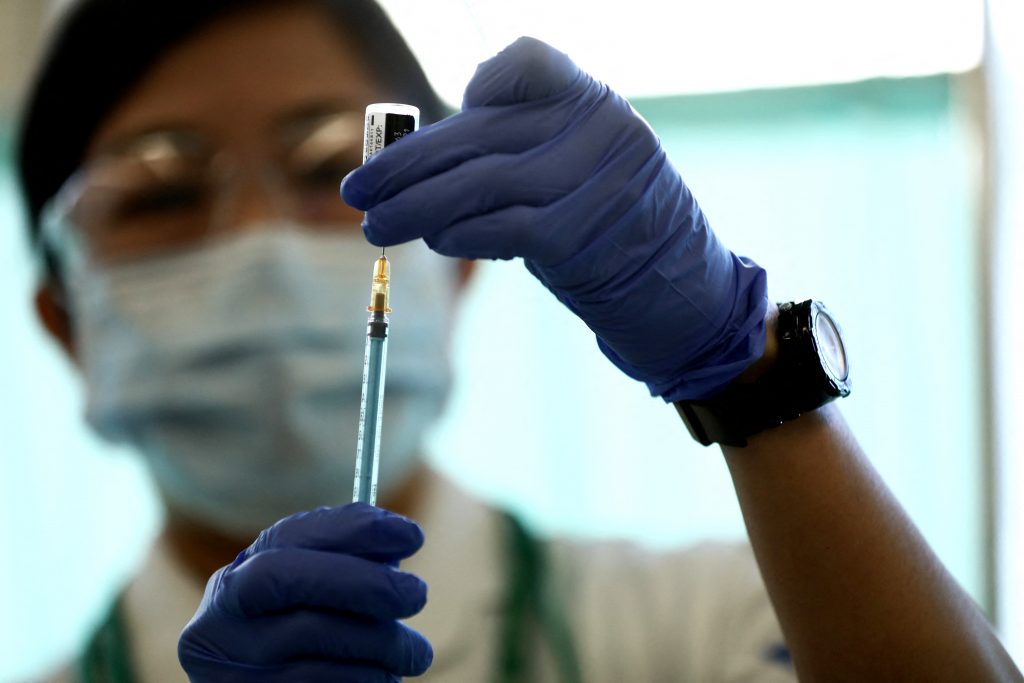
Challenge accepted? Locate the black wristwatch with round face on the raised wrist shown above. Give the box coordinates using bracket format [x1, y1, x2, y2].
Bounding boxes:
[676, 300, 850, 446]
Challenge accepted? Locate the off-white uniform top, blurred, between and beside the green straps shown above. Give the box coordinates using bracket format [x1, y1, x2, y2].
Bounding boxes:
[39, 477, 796, 683]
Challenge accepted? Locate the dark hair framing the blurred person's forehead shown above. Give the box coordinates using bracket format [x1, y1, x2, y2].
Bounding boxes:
[15, 0, 446, 265]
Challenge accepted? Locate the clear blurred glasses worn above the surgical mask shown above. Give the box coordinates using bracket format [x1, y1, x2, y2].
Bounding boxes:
[42, 111, 362, 264]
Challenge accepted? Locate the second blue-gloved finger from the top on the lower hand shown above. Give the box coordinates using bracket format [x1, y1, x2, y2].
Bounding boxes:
[210, 548, 427, 618]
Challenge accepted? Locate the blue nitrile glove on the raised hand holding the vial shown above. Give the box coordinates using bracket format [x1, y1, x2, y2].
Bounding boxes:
[342, 38, 768, 400]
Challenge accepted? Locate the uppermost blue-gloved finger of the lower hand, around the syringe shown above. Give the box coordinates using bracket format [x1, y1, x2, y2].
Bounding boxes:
[239, 503, 424, 566]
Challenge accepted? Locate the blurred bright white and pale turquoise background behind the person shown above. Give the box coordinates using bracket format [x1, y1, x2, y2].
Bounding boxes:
[0, 0, 1024, 681]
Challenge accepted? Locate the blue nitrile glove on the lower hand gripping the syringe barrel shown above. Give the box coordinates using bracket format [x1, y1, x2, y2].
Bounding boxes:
[178, 503, 433, 683]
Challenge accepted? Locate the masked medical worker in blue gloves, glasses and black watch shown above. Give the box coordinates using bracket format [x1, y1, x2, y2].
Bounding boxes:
[18, 0, 1020, 683]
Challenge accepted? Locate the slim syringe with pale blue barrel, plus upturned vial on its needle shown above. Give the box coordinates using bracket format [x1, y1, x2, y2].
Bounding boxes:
[352, 104, 420, 505]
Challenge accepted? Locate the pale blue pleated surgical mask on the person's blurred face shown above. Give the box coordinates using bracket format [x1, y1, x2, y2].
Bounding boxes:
[70, 225, 457, 536]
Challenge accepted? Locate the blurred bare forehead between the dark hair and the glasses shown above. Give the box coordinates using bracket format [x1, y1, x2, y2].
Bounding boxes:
[87, 2, 384, 156]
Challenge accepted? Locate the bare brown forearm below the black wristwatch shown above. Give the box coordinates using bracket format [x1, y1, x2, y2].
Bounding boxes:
[723, 404, 1022, 682]
